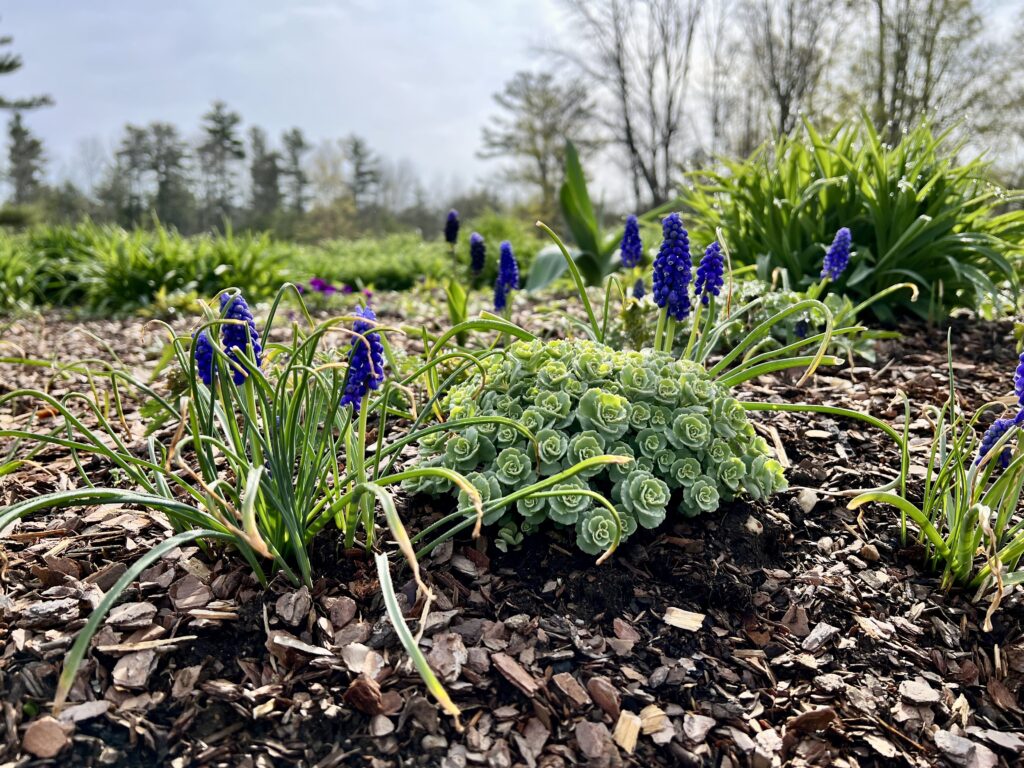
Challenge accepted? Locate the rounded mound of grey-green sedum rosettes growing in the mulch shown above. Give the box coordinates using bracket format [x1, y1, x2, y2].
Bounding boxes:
[408, 340, 785, 554]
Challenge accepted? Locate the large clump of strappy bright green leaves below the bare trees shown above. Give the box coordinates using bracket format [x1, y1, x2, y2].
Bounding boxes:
[682, 114, 1024, 318]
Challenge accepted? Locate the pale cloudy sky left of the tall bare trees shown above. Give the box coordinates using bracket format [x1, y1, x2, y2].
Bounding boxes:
[0, 0, 562, 195]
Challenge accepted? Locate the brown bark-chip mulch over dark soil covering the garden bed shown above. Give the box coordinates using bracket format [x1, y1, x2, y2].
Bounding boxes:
[0, 315, 1024, 768]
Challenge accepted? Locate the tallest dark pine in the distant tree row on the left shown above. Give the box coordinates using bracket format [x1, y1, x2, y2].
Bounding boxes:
[198, 101, 246, 227]
